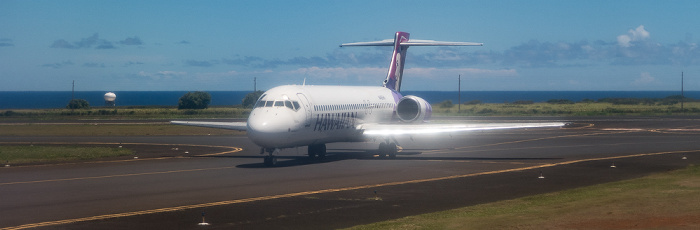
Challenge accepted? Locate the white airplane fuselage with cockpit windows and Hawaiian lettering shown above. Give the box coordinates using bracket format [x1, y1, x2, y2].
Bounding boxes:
[247, 85, 402, 148]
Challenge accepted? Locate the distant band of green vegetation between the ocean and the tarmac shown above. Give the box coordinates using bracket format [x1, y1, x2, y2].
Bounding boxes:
[0, 94, 700, 120]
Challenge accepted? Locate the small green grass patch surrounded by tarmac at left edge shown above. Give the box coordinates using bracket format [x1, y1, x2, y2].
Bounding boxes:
[0, 145, 133, 165]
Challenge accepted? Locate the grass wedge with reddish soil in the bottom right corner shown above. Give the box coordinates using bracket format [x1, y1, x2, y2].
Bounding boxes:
[350, 166, 700, 229]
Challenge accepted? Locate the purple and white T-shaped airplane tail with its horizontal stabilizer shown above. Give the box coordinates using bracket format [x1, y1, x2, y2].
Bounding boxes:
[340, 32, 483, 92]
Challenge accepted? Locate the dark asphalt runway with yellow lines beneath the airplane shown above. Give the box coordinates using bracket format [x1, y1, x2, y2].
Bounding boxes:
[0, 117, 700, 229]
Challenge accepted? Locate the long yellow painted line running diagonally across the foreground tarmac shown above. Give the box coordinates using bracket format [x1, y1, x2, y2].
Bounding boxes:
[1, 150, 700, 230]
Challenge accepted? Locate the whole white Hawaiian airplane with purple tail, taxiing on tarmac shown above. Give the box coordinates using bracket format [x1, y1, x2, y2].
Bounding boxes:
[172, 32, 564, 166]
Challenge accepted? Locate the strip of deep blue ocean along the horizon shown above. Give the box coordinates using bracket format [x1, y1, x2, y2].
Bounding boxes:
[0, 91, 700, 110]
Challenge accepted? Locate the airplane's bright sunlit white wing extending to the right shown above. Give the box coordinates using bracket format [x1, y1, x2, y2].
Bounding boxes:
[357, 122, 566, 136]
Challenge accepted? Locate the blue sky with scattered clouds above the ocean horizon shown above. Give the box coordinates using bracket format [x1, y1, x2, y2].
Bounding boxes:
[0, 0, 700, 91]
